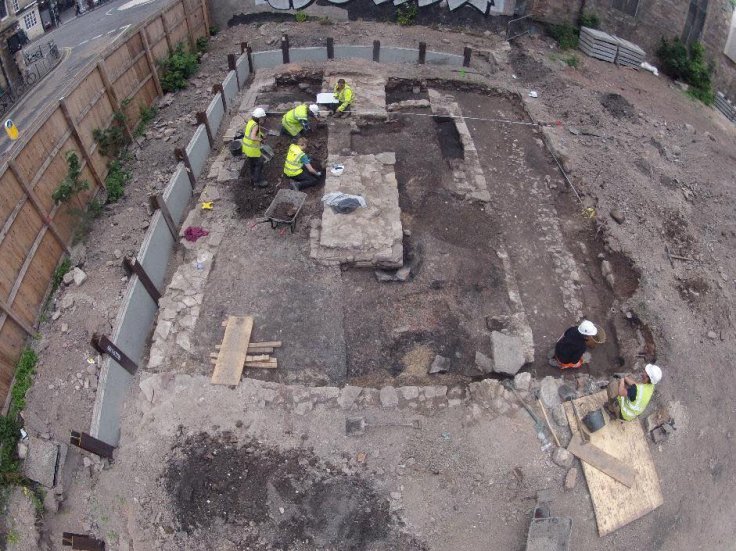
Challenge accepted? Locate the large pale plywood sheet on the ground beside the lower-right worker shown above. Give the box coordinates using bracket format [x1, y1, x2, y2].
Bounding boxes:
[564, 390, 664, 536]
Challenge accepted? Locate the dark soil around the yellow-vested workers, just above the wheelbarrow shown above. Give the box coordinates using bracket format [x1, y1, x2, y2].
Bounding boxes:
[232, 126, 327, 218]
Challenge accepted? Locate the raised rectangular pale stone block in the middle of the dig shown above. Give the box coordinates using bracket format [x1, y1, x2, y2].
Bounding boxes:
[311, 153, 404, 268]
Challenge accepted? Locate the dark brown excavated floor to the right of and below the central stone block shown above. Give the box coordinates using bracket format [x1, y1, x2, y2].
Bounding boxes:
[342, 111, 508, 385]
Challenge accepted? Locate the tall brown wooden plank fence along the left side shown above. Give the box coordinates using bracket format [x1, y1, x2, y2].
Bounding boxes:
[0, 0, 209, 401]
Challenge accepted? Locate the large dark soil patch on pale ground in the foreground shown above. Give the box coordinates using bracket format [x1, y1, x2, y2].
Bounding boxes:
[164, 433, 420, 550]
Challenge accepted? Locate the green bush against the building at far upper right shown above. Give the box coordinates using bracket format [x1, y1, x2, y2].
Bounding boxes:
[657, 38, 715, 105]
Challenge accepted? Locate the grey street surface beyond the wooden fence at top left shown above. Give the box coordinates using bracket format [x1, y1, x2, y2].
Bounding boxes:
[0, 0, 177, 161]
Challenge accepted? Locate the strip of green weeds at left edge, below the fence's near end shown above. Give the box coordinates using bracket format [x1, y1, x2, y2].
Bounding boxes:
[0, 348, 38, 485]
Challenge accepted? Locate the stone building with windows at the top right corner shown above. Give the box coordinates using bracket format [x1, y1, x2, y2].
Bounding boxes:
[531, 0, 736, 98]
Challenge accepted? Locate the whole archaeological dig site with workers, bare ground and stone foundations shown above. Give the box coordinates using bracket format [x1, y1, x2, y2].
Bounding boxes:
[0, 1, 736, 551]
